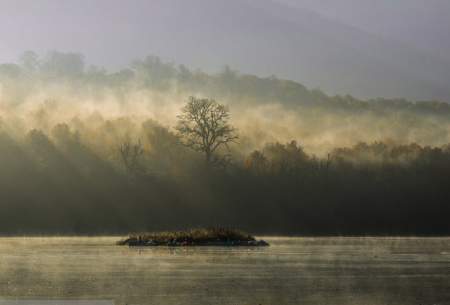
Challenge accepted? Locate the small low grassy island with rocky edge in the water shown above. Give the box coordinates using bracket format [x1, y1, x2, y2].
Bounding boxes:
[117, 228, 269, 247]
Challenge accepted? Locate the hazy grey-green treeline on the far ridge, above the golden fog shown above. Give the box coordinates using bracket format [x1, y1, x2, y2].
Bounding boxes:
[0, 51, 450, 116]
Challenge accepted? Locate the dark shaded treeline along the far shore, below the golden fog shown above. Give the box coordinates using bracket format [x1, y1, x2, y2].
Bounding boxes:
[0, 121, 450, 235]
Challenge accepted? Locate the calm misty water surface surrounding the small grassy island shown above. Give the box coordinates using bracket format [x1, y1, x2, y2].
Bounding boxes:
[0, 237, 450, 305]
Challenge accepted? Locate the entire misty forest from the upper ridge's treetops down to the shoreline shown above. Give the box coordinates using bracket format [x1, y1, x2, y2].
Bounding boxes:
[0, 51, 450, 235]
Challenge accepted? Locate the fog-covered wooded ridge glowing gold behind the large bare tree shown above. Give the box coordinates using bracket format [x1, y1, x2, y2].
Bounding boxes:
[0, 51, 450, 156]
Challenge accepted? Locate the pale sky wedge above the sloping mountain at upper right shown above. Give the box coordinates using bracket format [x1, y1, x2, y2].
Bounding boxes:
[280, 0, 450, 61]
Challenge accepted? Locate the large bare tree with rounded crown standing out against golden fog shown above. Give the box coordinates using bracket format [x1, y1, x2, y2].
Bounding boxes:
[176, 96, 238, 163]
